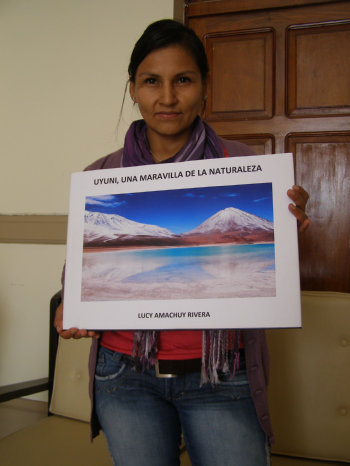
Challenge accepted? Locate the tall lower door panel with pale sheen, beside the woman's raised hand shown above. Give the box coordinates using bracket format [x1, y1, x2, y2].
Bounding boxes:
[286, 131, 350, 291]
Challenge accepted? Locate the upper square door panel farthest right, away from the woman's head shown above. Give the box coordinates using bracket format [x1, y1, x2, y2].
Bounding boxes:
[287, 20, 350, 117]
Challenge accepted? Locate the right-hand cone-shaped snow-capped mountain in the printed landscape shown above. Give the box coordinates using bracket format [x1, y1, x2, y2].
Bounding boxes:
[186, 207, 273, 235]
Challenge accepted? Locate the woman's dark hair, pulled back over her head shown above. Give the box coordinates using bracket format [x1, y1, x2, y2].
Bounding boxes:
[128, 19, 209, 82]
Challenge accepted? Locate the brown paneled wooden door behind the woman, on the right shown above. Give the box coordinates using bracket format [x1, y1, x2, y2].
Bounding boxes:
[185, 0, 350, 292]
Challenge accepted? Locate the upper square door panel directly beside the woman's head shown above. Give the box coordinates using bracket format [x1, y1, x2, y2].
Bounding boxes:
[204, 28, 275, 121]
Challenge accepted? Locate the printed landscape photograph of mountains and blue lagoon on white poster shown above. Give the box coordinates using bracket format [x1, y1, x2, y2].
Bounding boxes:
[81, 183, 276, 301]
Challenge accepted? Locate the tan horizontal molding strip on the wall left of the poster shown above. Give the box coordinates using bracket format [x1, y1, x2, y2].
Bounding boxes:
[0, 215, 68, 244]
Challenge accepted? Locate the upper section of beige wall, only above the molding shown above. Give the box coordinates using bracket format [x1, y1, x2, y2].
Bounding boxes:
[0, 0, 173, 214]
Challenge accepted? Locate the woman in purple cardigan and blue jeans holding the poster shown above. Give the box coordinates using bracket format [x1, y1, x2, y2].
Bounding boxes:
[55, 20, 309, 466]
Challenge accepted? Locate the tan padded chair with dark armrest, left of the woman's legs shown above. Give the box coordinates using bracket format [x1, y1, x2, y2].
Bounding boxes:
[0, 293, 190, 466]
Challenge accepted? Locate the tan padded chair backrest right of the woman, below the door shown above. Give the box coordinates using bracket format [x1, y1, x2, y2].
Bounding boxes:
[267, 291, 350, 461]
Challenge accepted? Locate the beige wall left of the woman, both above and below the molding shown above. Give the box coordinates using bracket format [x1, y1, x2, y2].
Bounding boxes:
[0, 0, 173, 400]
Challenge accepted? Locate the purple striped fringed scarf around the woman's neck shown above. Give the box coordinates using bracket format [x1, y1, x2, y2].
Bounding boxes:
[121, 117, 239, 384]
